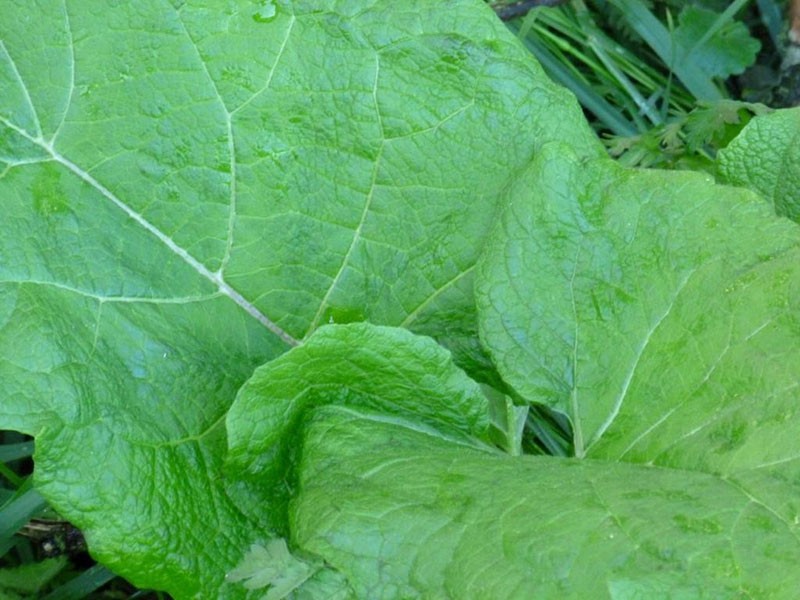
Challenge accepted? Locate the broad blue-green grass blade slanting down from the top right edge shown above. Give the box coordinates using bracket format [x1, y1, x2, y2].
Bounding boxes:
[609, 0, 723, 101]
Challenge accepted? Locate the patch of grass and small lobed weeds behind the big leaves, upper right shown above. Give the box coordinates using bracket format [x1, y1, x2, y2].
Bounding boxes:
[495, 0, 792, 170]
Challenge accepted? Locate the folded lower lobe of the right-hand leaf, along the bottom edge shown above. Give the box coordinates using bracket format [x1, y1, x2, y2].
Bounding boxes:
[293, 407, 800, 599]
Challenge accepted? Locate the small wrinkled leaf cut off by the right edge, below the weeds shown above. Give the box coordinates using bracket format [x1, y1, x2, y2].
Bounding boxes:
[718, 108, 800, 221]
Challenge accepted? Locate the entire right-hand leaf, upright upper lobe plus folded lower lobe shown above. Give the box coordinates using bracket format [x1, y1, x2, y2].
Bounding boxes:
[278, 144, 800, 600]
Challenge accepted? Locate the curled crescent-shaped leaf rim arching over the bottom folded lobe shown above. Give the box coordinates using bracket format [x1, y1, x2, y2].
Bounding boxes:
[227, 323, 490, 500]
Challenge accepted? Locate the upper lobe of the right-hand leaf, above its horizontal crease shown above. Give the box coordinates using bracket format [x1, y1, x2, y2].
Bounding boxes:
[477, 145, 800, 454]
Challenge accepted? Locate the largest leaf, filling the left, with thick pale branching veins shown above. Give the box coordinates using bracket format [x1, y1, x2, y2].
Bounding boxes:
[0, 0, 600, 598]
